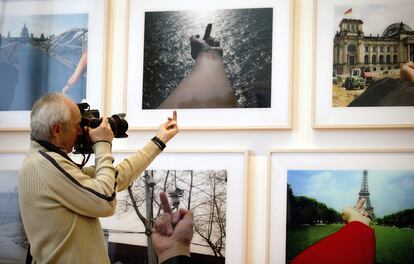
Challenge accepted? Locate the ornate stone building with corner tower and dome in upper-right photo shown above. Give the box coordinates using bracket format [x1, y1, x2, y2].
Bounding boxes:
[333, 19, 414, 76]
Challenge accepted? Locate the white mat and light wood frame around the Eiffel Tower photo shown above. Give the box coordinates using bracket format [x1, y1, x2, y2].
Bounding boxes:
[266, 149, 414, 264]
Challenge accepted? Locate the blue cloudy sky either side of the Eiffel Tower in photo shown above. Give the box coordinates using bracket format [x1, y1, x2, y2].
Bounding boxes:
[288, 170, 414, 217]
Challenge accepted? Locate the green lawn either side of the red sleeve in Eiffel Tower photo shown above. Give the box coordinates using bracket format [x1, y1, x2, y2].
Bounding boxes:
[286, 224, 414, 264]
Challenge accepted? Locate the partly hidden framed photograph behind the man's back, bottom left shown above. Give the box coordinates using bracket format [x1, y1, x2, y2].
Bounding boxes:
[0, 152, 29, 263]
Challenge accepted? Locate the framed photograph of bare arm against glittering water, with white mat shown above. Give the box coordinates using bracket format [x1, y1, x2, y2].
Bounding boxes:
[125, 0, 293, 129]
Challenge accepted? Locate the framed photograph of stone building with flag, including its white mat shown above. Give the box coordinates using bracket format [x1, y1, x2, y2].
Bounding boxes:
[313, 0, 414, 128]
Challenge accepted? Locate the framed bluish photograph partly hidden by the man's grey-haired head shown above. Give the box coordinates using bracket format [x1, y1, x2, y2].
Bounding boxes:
[0, 0, 107, 130]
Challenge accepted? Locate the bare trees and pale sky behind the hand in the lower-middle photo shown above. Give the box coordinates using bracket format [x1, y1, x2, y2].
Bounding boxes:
[104, 170, 227, 263]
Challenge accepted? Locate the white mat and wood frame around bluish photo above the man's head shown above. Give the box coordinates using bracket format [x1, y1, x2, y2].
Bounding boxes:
[0, 0, 109, 131]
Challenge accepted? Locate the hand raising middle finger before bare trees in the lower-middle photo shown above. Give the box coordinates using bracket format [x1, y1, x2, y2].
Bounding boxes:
[152, 192, 193, 263]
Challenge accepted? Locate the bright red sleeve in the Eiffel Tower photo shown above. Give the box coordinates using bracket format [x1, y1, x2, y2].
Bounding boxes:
[292, 221, 375, 264]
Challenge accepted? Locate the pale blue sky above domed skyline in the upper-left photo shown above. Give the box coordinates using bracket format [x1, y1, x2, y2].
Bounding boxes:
[0, 14, 88, 37]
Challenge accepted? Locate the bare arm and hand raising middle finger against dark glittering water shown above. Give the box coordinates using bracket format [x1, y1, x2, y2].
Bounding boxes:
[158, 24, 239, 109]
